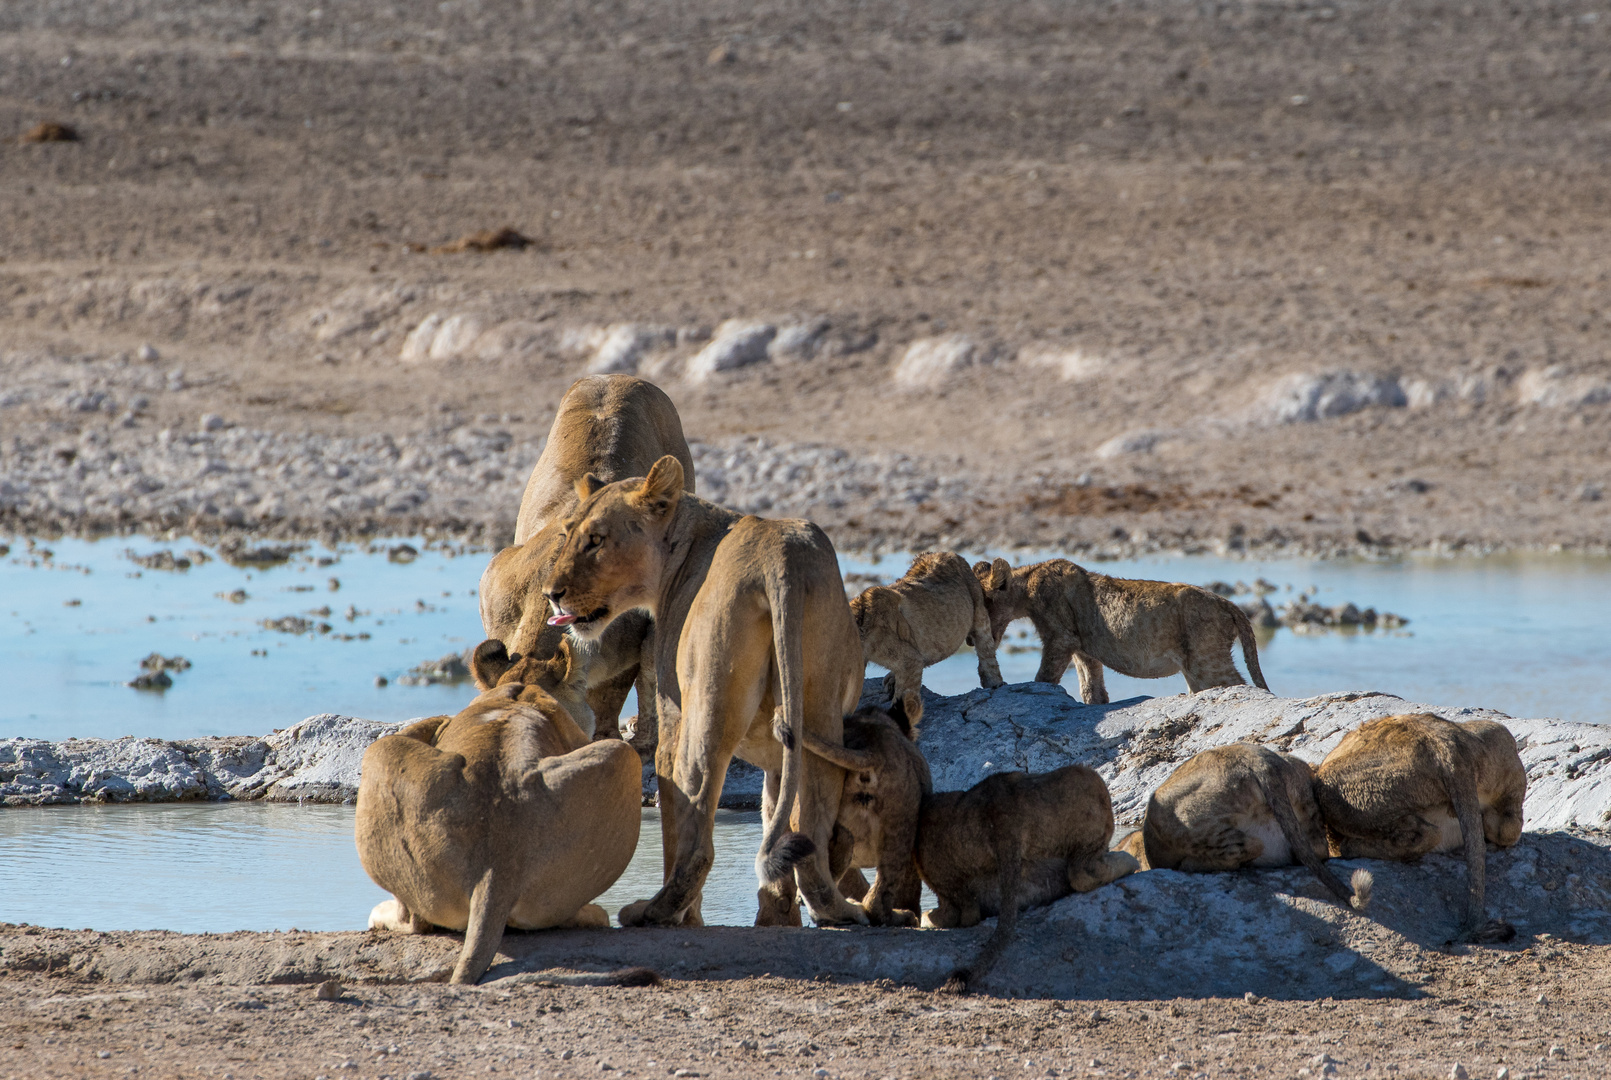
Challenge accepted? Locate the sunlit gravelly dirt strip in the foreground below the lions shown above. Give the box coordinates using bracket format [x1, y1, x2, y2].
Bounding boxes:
[0, 927, 1611, 1080]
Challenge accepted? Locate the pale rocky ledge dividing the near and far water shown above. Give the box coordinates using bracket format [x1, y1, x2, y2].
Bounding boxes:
[0, 680, 1611, 830]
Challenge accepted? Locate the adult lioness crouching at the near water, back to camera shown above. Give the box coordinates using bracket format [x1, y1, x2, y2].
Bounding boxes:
[356, 643, 643, 983]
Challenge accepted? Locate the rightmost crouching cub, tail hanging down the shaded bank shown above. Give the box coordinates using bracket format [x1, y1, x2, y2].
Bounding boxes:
[1315, 712, 1527, 941]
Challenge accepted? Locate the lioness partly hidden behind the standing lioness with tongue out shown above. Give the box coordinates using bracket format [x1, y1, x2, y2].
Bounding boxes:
[475, 376, 694, 743]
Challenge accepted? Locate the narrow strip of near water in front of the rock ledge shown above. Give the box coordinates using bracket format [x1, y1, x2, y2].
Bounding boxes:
[0, 803, 760, 933]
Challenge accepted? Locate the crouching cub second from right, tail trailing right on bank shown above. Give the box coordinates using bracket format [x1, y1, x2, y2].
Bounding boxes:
[1120, 743, 1371, 909]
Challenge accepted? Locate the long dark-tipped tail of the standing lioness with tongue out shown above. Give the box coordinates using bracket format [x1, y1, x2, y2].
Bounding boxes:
[756, 574, 817, 887]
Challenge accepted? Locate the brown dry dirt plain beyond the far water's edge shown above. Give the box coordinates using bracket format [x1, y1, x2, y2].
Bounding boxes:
[0, 0, 1611, 551]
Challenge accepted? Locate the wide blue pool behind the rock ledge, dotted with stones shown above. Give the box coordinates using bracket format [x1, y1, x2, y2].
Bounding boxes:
[0, 538, 1611, 738]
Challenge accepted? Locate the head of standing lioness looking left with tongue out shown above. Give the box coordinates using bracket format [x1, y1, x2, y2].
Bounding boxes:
[545, 456, 683, 640]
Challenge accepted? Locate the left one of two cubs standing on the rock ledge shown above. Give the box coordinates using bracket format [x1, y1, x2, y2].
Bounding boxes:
[851, 551, 1002, 727]
